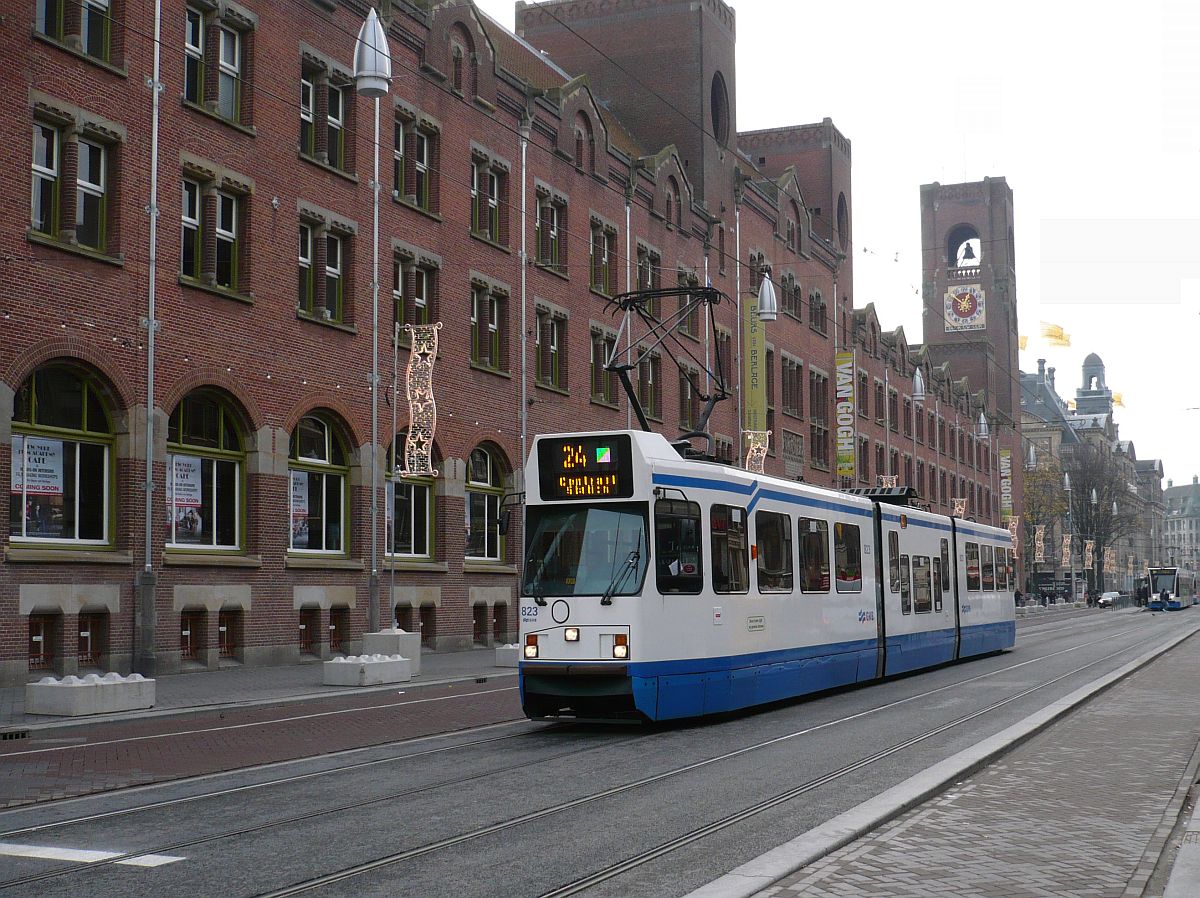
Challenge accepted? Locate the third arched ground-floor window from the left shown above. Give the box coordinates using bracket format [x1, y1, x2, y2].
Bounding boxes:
[288, 414, 349, 555]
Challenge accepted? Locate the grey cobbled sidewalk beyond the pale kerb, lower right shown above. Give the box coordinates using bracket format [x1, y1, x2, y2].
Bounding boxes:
[756, 637, 1200, 898]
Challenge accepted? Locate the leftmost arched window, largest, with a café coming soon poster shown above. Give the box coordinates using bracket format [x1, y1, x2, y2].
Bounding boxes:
[8, 364, 114, 545]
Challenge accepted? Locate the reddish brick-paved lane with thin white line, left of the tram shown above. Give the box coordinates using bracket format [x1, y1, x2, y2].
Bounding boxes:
[0, 677, 523, 808]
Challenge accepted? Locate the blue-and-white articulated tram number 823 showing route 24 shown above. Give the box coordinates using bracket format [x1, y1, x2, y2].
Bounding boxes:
[520, 431, 1015, 720]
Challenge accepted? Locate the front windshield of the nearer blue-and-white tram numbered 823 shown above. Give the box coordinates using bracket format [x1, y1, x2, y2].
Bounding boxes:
[522, 503, 649, 598]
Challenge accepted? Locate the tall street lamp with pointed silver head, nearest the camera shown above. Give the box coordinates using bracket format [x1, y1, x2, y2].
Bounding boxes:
[354, 8, 396, 633]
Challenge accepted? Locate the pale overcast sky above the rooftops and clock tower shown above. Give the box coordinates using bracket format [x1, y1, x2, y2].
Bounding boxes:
[479, 0, 1200, 486]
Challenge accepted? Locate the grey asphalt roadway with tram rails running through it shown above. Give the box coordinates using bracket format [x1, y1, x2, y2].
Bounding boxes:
[0, 612, 1180, 898]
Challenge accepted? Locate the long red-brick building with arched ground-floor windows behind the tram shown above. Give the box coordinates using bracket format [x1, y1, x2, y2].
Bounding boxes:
[0, 0, 1019, 683]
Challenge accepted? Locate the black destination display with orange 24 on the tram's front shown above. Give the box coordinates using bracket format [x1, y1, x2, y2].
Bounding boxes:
[538, 433, 634, 502]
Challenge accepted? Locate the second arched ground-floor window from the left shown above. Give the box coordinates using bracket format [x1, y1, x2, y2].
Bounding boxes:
[167, 391, 246, 550]
